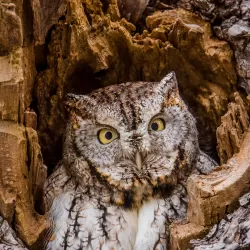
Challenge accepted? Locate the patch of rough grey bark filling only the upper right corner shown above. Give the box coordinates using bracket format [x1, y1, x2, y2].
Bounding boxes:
[189, 0, 250, 94]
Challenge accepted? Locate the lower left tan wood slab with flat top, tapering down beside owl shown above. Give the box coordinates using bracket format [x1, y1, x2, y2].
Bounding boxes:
[0, 121, 47, 246]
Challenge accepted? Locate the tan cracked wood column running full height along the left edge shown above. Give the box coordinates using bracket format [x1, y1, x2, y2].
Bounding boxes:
[0, 0, 48, 246]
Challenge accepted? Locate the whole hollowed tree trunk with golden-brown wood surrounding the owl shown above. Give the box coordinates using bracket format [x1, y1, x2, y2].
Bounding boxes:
[0, 0, 250, 249]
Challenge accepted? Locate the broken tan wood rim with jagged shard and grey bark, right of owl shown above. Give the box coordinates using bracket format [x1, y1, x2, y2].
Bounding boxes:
[168, 92, 250, 247]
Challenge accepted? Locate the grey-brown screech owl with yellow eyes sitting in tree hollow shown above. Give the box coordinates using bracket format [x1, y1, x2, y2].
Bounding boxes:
[46, 72, 216, 250]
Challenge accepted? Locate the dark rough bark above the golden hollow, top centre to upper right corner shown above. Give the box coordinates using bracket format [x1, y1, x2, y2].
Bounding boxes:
[118, 0, 250, 94]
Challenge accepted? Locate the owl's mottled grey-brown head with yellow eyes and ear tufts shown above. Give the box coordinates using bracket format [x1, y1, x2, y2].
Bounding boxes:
[64, 73, 199, 203]
